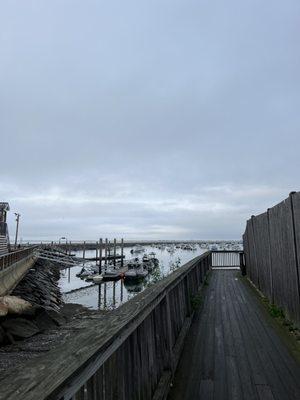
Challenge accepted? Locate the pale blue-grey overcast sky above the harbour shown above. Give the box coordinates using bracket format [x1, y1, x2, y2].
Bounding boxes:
[0, 0, 300, 240]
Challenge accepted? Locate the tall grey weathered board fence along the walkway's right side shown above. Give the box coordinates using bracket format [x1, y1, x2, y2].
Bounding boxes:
[243, 192, 300, 326]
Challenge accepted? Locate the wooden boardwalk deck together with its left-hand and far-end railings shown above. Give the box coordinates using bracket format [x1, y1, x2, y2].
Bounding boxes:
[0, 247, 300, 400]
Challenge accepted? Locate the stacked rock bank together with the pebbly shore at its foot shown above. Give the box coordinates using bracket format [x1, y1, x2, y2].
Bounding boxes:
[0, 260, 103, 372]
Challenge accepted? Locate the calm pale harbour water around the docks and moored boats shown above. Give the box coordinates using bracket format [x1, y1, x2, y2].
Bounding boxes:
[59, 246, 205, 310]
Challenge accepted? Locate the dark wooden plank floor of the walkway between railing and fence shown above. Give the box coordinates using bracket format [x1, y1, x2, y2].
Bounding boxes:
[168, 270, 300, 400]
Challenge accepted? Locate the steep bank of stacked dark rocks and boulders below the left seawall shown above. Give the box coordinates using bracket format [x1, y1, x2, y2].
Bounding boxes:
[0, 260, 63, 346]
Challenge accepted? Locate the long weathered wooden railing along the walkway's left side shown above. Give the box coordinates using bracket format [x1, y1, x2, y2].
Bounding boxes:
[0, 248, 244, 400]
